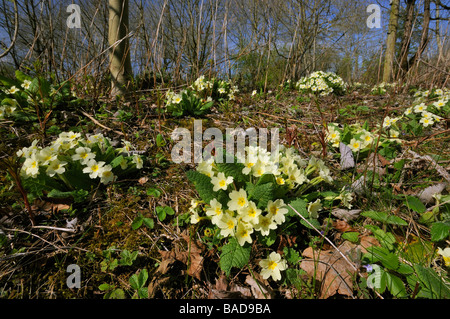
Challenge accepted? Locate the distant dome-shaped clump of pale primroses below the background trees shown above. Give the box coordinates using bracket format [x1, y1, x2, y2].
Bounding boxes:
[296, 71, 347, 96]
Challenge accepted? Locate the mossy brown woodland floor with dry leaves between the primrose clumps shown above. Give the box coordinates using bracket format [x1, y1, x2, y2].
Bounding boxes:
[0, 87, 450, 299]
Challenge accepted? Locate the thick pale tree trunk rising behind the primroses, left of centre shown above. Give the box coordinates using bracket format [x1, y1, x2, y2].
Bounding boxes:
[108, 0, 133, 96]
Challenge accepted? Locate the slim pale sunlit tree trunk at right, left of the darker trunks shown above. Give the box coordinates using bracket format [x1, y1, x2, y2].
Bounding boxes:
[383, 0, 400, 82]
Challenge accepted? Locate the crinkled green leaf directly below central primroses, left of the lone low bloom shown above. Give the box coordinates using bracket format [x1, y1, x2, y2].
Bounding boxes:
[219, 237, 251, 276]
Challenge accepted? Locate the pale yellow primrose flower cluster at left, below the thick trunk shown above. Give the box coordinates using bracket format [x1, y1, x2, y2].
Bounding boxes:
[17, 132, 143, 184]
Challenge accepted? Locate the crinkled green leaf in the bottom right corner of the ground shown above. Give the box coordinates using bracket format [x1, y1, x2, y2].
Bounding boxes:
[414, 264, 450, 299]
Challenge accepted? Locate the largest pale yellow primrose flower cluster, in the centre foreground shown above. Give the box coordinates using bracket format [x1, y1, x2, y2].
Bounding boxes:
[189, 146, 332, 246]
